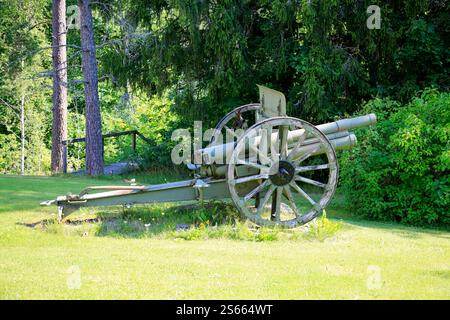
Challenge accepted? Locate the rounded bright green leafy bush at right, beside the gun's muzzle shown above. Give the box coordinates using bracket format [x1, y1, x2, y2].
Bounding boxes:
[340, 90, 450, 225]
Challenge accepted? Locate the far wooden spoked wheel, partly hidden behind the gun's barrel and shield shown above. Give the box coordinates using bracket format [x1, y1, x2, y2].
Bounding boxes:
[209, 103, 261, 146]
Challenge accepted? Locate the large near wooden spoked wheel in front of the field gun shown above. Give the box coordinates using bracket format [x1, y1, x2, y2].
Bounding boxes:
[227, 117, 338, 228]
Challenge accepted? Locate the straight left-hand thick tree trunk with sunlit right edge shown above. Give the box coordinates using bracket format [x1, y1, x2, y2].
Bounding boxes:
[51, 0, 67, 173]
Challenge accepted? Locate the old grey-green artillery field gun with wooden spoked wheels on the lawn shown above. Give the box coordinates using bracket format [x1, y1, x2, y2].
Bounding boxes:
[41, 86, 376, 228]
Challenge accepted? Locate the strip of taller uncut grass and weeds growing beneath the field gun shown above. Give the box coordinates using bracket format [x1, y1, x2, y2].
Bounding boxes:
[21, 201, 342, 241]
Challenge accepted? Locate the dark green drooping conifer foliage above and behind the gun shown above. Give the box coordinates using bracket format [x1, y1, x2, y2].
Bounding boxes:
[104, 0, 450, 123]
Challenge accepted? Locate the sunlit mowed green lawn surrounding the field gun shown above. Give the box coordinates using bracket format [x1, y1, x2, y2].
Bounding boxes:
[0, 175, 450, 299]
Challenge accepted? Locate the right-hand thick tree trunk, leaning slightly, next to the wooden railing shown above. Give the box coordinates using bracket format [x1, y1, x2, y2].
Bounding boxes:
[78, 0, 103, 176]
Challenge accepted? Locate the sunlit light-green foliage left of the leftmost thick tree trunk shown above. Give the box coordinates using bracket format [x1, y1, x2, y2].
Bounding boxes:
[0, 0, 51, 173]
